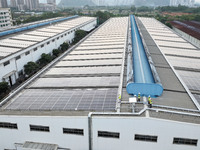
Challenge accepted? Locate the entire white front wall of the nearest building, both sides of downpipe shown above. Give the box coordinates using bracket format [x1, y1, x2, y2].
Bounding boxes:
[0, 116, 200, 150]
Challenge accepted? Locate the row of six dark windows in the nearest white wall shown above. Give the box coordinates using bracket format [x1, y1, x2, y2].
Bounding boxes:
[0, 122, 198, 146]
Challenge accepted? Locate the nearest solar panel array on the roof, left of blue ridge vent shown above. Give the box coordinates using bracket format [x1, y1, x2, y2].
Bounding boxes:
[6, 89, 118, 111]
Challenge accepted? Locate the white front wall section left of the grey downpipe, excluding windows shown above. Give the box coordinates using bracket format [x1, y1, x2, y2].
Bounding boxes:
[0, 116, 88, 150]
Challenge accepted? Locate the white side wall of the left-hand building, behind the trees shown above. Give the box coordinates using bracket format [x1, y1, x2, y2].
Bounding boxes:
[0, 20, 97, 84]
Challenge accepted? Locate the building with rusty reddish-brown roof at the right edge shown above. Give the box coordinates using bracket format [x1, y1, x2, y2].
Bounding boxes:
[170, 21, 200, 48]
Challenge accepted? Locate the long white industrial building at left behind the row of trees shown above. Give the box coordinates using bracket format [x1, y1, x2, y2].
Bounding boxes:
[0, 16, 97, 86]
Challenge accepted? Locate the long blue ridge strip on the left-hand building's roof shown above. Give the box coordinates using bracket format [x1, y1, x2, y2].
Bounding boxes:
[0, 15, 78, 36]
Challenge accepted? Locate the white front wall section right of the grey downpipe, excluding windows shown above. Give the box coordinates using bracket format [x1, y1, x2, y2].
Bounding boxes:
[93, 117, 200, 150]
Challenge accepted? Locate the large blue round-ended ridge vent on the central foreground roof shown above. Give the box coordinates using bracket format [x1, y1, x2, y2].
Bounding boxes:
[126, 15, 163, 97]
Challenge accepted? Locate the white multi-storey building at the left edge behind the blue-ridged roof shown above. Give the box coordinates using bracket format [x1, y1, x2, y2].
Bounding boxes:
[0, 8, 12, 29]
